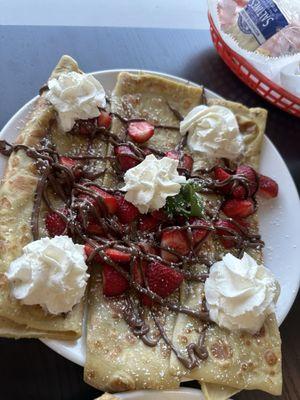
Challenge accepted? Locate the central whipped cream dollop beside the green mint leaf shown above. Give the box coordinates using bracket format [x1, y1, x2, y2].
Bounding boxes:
[122, 154, 186, 214]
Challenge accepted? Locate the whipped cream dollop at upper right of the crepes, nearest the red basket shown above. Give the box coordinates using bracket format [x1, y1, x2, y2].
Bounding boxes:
[180, 105, 243, 160]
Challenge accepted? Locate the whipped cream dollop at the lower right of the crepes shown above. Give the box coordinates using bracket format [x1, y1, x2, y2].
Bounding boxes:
[205, 253, 280, 334]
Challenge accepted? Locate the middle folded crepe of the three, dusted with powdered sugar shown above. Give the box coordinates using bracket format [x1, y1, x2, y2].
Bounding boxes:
[84, 73, 202, 391]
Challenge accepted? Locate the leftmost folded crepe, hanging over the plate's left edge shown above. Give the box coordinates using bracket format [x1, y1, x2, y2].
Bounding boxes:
[0, 56, 101, 340]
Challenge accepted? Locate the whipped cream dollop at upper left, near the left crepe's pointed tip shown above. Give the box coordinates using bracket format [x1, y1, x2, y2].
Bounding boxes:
[46, 71, 106, 132]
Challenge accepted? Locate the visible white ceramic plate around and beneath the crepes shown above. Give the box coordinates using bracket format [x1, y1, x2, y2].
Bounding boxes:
[0, 70, 300, 365]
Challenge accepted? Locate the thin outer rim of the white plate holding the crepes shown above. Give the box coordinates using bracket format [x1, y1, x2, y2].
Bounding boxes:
[0, 68, 300, 366]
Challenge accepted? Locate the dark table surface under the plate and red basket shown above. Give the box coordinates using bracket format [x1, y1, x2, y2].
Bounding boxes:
[0, 26, 300, 400]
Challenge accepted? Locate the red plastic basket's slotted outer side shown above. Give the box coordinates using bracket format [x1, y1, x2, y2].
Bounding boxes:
[208, 14, 300, 118]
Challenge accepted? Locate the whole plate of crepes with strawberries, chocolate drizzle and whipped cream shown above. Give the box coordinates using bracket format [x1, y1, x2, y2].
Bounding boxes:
[0, 56, 299, 400]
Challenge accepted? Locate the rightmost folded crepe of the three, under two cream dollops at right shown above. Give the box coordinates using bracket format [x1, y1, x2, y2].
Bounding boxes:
[171, 100, 282, 399]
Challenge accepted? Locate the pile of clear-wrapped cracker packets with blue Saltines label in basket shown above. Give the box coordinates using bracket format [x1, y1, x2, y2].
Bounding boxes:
[218, 0, 300, 56]
